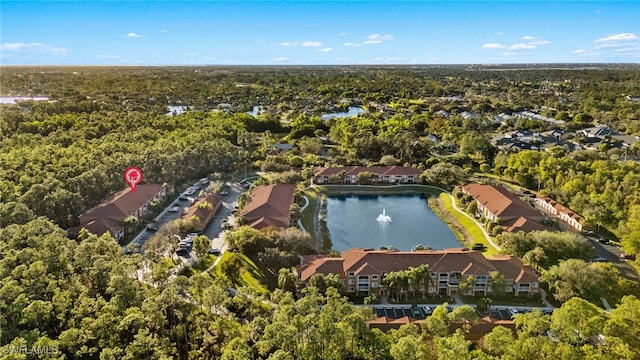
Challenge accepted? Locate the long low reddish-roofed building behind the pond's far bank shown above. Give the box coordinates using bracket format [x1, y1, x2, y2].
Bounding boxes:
[313, 166, 420, 184]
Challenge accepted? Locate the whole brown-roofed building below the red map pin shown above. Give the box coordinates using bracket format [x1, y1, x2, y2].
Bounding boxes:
[74, 184, 170, 240]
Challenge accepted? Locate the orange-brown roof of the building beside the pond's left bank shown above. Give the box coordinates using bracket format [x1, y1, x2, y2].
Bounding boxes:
[240, 184, 296, 222]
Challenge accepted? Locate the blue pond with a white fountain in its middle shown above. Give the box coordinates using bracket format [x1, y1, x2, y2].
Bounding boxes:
[327, 194, 463, 251]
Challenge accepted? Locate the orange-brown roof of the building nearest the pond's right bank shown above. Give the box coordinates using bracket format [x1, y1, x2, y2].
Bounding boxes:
[462, 184, 542, 218]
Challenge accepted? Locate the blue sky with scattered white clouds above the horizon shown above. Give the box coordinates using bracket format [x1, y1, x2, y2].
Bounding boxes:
[0, 0, 640, 65]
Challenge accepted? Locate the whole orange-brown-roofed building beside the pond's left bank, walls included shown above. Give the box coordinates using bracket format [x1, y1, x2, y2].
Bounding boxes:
[240, 184, 296, 229]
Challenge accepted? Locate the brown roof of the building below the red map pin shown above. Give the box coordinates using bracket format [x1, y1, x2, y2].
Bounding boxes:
[79, 184, 164, 224]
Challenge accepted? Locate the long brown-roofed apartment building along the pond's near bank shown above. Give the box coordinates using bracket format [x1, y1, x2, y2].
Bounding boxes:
[296, 248, 539, 295]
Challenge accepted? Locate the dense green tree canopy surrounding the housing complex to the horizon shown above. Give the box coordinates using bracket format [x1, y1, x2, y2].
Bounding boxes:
[0, 64, 640, 359]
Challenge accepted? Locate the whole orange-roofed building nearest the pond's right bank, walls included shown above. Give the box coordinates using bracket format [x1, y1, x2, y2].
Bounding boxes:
[460, 184, 545, 232]
